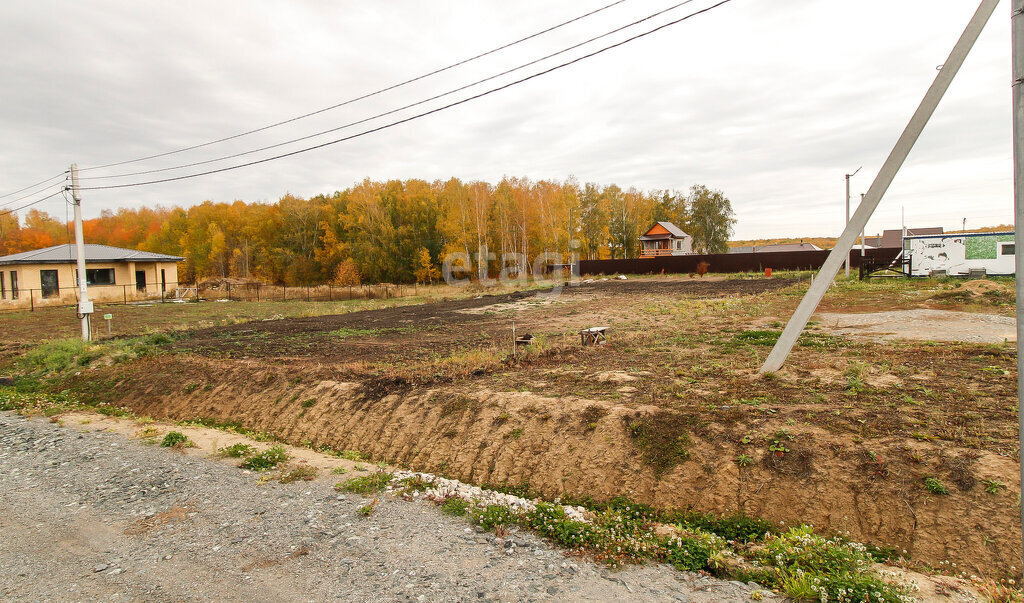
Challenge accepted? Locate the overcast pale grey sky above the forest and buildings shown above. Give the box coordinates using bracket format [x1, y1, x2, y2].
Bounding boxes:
[0, 0, 1013, 239]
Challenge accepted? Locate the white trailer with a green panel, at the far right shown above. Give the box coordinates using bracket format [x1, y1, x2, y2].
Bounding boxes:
[903, 232, 1016, 276]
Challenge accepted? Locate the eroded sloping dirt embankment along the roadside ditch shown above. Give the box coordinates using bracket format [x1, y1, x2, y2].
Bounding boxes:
[90, 356, 1021, 575]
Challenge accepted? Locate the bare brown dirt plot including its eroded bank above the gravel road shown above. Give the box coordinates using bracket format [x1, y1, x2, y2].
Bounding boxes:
[8, 277, 1022, 577]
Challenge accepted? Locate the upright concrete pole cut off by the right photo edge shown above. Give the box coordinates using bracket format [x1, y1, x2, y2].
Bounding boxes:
[1007, 0, 1024, 569]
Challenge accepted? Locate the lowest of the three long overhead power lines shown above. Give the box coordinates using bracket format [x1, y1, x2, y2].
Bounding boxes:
[80, 0, 732, 190]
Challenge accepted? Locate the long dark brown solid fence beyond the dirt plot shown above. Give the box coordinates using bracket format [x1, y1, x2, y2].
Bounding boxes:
[580, 249, 900, 275]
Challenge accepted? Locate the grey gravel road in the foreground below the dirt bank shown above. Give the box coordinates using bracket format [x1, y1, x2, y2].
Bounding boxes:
[0, 413, 773, 601]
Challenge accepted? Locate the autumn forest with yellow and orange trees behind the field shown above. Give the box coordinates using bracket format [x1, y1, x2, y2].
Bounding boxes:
[0, 177, 734, 286]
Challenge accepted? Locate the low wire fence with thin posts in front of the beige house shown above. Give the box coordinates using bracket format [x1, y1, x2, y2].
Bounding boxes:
[0, 283, 419, 312]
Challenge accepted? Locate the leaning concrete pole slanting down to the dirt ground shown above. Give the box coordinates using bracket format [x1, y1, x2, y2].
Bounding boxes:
[761, 0, 999, 373]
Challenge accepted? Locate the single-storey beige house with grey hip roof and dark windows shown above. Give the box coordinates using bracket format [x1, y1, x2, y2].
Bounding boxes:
[0, 245, 184, 306]
